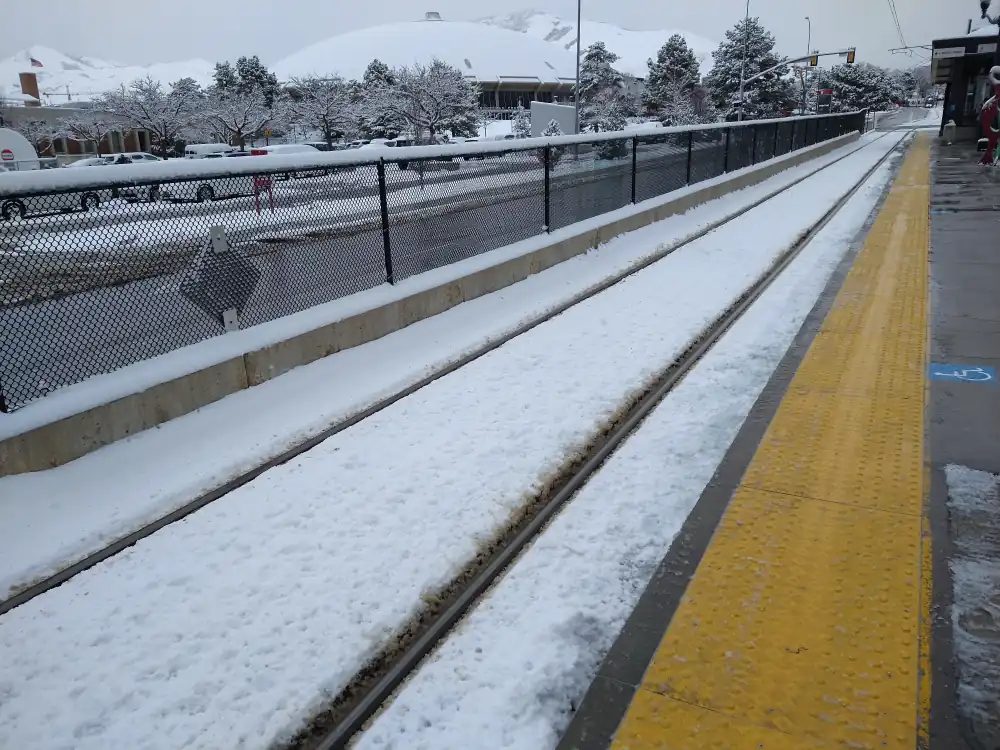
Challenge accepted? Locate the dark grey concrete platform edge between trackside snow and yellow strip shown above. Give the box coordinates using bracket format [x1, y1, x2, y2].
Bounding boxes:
[557, 132, 909, 750]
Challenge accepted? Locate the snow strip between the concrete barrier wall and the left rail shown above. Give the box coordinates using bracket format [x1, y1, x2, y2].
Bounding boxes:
[0, 134, 889, 597]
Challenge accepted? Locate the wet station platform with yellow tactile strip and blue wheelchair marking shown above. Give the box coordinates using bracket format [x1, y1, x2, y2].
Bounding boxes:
[560, 133, 1000, 750]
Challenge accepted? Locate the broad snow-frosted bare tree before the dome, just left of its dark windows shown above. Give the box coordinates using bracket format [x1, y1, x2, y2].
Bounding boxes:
[363, 58, 479, 140]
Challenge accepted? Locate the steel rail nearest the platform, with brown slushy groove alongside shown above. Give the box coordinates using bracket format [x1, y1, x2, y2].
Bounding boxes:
[276, 136, 904, 750]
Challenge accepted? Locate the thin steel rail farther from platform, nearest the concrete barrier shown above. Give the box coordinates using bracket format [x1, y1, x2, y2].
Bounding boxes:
[0, 133, 891, 615]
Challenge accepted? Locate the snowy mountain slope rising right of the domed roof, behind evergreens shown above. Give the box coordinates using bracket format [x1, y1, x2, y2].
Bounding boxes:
[481, 10, 719, 78]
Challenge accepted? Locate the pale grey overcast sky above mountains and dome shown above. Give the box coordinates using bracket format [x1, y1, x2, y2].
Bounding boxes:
[0, 0, 979, 67]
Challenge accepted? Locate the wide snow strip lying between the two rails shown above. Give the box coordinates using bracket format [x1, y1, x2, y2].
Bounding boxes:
[0, 132, 908, 750]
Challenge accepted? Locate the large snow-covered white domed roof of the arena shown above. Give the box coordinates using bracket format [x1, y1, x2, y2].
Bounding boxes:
[272, 13, 576, 83]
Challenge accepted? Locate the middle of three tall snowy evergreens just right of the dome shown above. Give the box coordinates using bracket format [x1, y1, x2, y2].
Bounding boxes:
[643, 34, 700, 125]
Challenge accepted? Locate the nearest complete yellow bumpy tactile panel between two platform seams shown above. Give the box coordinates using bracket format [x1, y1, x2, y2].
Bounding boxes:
[632, 489, 921, 750]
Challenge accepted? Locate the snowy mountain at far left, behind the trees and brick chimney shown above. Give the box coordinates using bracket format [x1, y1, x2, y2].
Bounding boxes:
[0, 45, 215, 104]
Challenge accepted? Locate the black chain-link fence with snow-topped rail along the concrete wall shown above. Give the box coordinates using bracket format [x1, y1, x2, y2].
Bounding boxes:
[0, 112, 865, 411]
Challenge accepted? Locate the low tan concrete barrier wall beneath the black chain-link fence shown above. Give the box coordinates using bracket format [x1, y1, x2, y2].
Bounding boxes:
[0, 133, 859, 476]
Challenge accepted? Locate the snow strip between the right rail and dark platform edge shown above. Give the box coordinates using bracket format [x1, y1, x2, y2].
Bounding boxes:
[355, 147, 908, 750]
